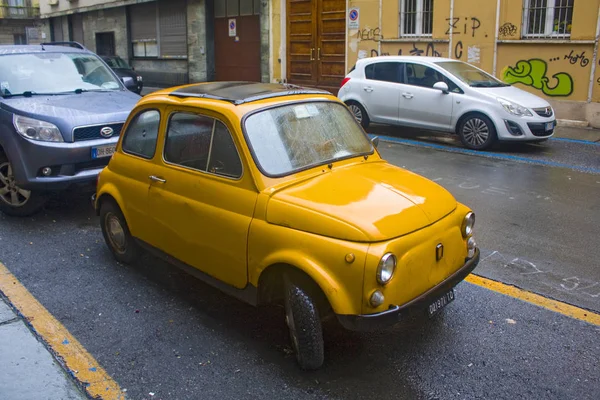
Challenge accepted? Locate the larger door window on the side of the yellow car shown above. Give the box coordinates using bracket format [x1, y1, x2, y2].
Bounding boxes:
[164, 112, 242, 178]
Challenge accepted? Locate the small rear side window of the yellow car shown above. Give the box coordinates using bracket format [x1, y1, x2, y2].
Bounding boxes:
[122, 110, 160, 159]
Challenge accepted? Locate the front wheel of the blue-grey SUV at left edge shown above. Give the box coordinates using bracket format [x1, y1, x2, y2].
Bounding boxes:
[0, 152, 48, 217]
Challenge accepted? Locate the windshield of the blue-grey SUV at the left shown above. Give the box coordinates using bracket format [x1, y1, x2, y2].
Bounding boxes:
[0, 53, 121, 96]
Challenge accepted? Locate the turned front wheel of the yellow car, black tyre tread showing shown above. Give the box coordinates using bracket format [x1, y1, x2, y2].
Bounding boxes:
[284, 276, 325, 370]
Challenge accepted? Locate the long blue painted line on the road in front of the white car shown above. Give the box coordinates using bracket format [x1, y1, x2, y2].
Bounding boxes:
[368, 133, 600, 174]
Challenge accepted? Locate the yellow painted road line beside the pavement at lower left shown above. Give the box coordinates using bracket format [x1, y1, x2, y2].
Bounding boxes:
[0, 263, 125, 400]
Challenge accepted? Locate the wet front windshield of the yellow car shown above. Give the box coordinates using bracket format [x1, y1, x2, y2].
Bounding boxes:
[245, 102, 373, 176]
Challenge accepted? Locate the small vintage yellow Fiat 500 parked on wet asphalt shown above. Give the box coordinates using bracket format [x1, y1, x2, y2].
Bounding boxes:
[94, 82, 479, 369]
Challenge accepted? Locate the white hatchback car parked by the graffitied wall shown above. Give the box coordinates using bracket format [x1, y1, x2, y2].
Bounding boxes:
[338, 56, 556, 150]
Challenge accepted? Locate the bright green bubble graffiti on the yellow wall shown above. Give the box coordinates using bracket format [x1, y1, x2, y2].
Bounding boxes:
[502, 58, 573, 97]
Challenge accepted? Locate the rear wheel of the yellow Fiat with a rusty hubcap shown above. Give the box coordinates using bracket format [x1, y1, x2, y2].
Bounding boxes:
[100, 200, 140, 264]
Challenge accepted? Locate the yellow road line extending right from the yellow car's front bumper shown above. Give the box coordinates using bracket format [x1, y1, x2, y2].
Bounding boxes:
[465, 274, 600, 326]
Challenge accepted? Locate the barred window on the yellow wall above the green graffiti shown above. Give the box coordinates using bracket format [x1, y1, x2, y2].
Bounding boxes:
[523, 0, 575, 38]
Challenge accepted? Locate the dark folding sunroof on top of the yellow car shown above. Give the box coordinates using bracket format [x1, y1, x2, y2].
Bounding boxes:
[169, 82, 331, 106]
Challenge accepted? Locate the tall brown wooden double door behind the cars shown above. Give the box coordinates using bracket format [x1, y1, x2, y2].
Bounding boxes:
[287, 0, 346, 94]
